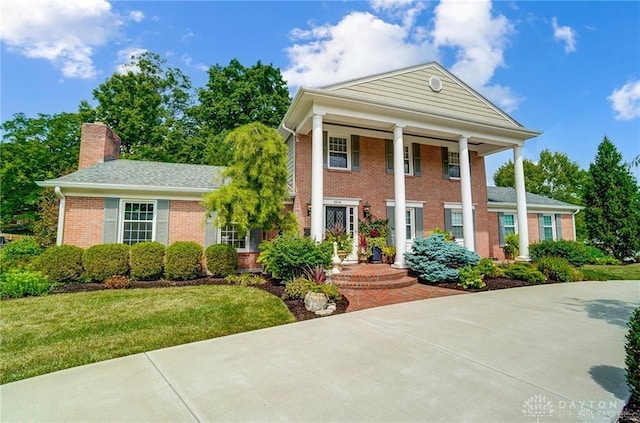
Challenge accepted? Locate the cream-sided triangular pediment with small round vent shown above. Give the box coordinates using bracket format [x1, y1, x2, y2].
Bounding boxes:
[323, 62, 522, 127]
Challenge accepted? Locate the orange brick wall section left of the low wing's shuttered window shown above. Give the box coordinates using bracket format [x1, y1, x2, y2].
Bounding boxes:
[62, 197, 104, 248]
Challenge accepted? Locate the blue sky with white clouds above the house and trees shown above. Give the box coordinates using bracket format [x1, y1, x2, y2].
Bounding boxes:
[0, 0, 640, 179]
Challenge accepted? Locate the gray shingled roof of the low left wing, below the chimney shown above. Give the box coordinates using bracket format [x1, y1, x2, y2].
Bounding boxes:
[42, 160, 224, 191]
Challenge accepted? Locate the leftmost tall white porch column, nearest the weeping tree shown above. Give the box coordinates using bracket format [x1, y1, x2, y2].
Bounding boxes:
[310, 114, 324, 242]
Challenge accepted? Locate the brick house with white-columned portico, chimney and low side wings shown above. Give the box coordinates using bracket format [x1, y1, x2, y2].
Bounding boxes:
[38, 63, 580, 269]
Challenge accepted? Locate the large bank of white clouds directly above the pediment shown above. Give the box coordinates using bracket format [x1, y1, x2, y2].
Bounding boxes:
[283, 0, 522, 112]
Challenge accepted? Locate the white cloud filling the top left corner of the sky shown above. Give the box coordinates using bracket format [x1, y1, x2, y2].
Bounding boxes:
[0, 0, 122, 79]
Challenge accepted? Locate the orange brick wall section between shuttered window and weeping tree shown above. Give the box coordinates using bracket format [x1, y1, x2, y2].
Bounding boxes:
[169, 200, 205, 245]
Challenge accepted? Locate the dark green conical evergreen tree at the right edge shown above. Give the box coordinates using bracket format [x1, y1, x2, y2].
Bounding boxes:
[583, 137, 640, 259]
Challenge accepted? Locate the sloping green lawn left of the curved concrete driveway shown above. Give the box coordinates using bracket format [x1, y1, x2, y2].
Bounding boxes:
[0, 285, 295, 383]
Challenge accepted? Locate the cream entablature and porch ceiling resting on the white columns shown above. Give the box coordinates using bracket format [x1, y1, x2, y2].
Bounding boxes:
[281, 88, 540, 156]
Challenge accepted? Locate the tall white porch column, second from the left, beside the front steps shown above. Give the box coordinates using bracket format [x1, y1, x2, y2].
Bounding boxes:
[393, 125, 407, 269]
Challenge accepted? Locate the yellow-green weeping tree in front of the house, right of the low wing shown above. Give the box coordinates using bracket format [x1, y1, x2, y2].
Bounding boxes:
[204, 122, 297, 238]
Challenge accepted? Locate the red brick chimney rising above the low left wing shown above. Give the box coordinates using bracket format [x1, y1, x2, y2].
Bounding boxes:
[78, 122, 121, 169]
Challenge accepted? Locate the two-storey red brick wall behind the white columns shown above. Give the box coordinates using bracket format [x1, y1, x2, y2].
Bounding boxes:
[294, 134, 490, 256]
